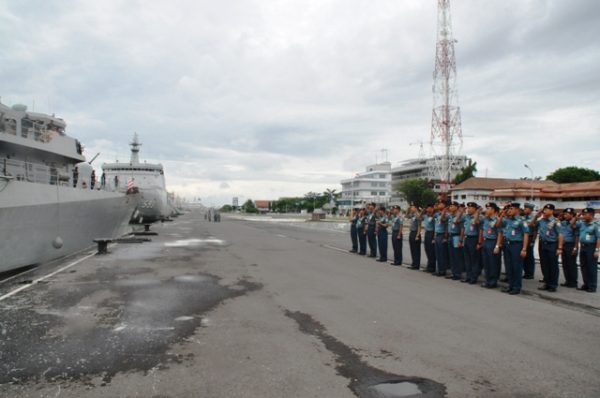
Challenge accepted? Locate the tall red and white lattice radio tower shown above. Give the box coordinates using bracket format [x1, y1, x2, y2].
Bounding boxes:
[430, 0, 462, 191]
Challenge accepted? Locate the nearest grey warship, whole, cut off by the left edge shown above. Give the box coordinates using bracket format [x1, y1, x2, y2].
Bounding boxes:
[0, 103, 138, 272]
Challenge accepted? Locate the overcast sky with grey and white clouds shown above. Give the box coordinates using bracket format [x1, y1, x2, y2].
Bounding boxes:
[0, 0, 600, 204]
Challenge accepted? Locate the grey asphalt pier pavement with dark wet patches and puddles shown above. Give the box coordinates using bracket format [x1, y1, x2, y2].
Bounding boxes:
[0, 212, 600, 398]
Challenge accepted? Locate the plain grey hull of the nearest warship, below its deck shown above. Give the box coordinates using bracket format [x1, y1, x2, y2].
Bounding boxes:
[0, 180, 139, 272]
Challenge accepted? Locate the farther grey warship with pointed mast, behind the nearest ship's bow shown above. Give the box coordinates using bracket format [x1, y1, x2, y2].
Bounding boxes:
[101, 134, 171, 224]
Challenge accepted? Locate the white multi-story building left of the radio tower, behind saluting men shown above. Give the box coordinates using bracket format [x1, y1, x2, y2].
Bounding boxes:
[338, 162, 392, 210]
